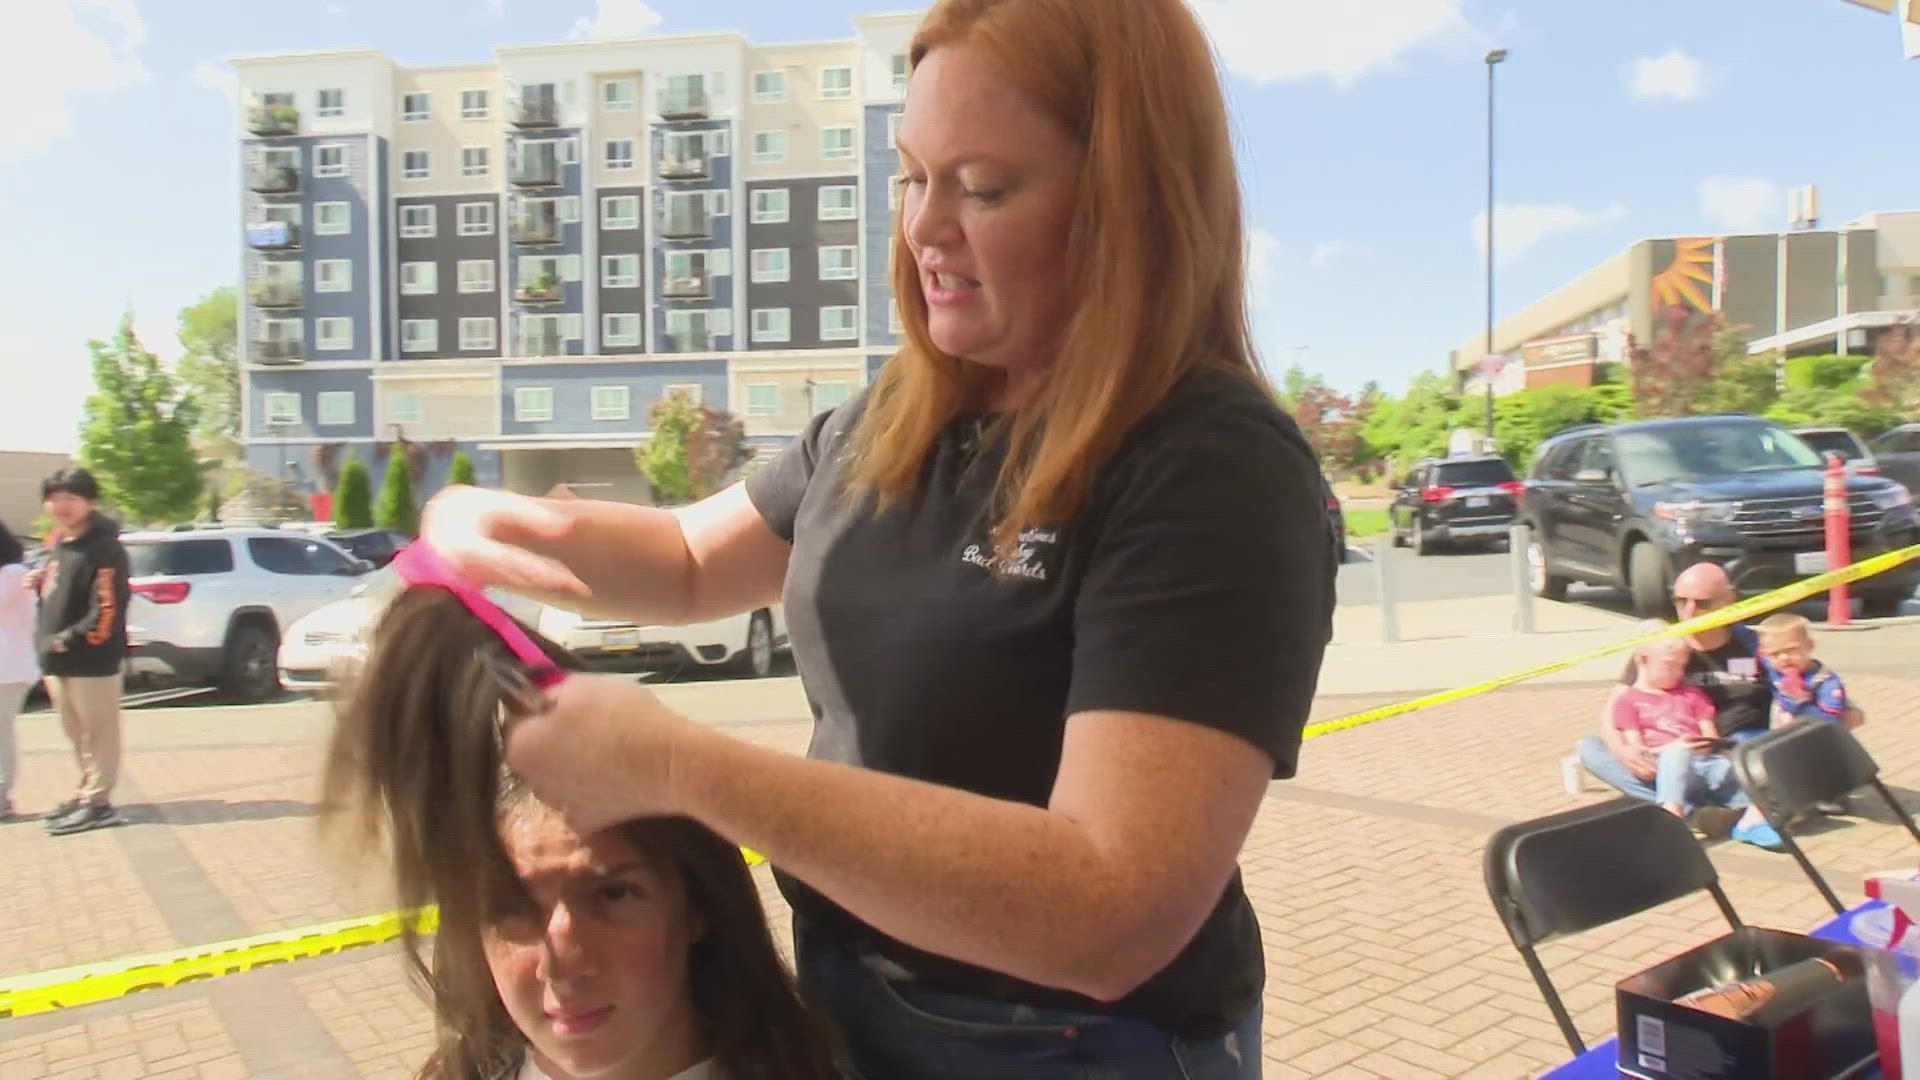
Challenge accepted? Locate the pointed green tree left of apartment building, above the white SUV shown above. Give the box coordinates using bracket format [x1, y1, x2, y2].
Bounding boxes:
[79, 311, 200, 525]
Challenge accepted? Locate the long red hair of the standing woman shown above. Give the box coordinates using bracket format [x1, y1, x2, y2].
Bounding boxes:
[851, 0, 1263, 550]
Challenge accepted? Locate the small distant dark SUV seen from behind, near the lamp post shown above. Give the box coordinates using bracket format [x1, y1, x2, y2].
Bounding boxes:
[1386, 454, 1521, 555]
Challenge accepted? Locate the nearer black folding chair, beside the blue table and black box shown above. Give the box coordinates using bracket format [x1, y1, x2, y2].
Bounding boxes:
[1486, 799, 1741, 1057]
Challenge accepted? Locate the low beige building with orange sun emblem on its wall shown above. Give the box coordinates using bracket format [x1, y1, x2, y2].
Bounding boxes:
[1448, 211, 1920, 394]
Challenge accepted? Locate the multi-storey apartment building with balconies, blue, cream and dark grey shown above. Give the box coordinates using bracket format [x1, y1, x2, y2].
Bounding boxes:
[234, 13, 920, 500]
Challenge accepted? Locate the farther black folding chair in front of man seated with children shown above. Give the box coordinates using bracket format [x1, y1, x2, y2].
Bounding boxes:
[1734, 721, 1920, 915]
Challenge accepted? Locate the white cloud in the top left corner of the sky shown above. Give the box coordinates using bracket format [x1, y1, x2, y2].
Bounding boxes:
[0, 0, 148, 161]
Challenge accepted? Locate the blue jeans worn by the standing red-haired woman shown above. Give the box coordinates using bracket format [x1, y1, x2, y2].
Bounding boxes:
[793, 924, 1261, 1080]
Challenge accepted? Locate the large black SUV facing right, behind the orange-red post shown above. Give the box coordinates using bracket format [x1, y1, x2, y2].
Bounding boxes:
[1521, 415, 1920, 617]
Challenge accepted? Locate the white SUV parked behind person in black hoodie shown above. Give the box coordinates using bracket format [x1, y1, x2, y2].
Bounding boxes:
[121, 528, 372, 701]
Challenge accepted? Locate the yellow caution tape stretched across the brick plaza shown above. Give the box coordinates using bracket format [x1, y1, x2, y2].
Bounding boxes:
[0, 544, 1920, 1020]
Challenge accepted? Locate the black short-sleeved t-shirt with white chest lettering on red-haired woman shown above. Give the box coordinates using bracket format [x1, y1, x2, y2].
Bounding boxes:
[747, 371, 1334, 1038]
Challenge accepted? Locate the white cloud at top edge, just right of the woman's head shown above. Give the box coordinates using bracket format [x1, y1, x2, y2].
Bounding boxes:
[1192, 0, 1478, 86]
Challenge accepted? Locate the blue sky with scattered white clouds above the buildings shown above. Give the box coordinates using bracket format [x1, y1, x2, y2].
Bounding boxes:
[0, 0, 1920, 450]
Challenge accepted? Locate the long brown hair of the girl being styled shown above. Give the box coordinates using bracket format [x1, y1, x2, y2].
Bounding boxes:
[323, 588, 839, 1080]
